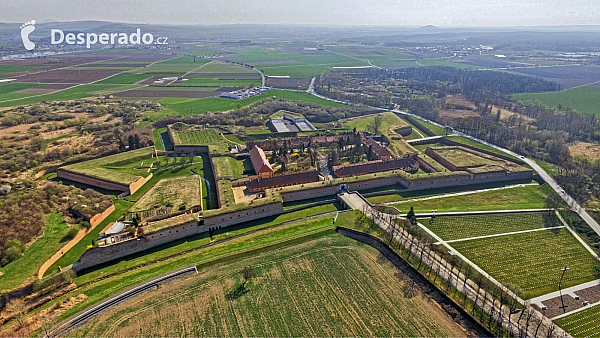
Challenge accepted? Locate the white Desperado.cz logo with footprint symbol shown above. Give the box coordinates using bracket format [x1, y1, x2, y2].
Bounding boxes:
[21, 20, 168, 50]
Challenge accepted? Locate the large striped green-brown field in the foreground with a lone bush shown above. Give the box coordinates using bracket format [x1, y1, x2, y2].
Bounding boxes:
[74, 236, 465, 337]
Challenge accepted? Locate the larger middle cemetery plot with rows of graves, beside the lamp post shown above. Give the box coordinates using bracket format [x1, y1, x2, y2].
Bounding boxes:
[450, 228, 600, 298]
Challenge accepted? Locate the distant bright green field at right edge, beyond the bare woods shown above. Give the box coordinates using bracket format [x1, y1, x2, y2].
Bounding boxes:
[513, 87, 600, 115]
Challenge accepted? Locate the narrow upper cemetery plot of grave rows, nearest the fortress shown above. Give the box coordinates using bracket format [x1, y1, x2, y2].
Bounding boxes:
[420, 210, 562, 241]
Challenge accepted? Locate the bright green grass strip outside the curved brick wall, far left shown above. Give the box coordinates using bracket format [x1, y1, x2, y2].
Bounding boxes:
[0, 211, 69, 290]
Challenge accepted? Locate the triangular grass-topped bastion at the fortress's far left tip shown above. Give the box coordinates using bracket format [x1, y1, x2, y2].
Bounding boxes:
[62, 147, 154, 185]
